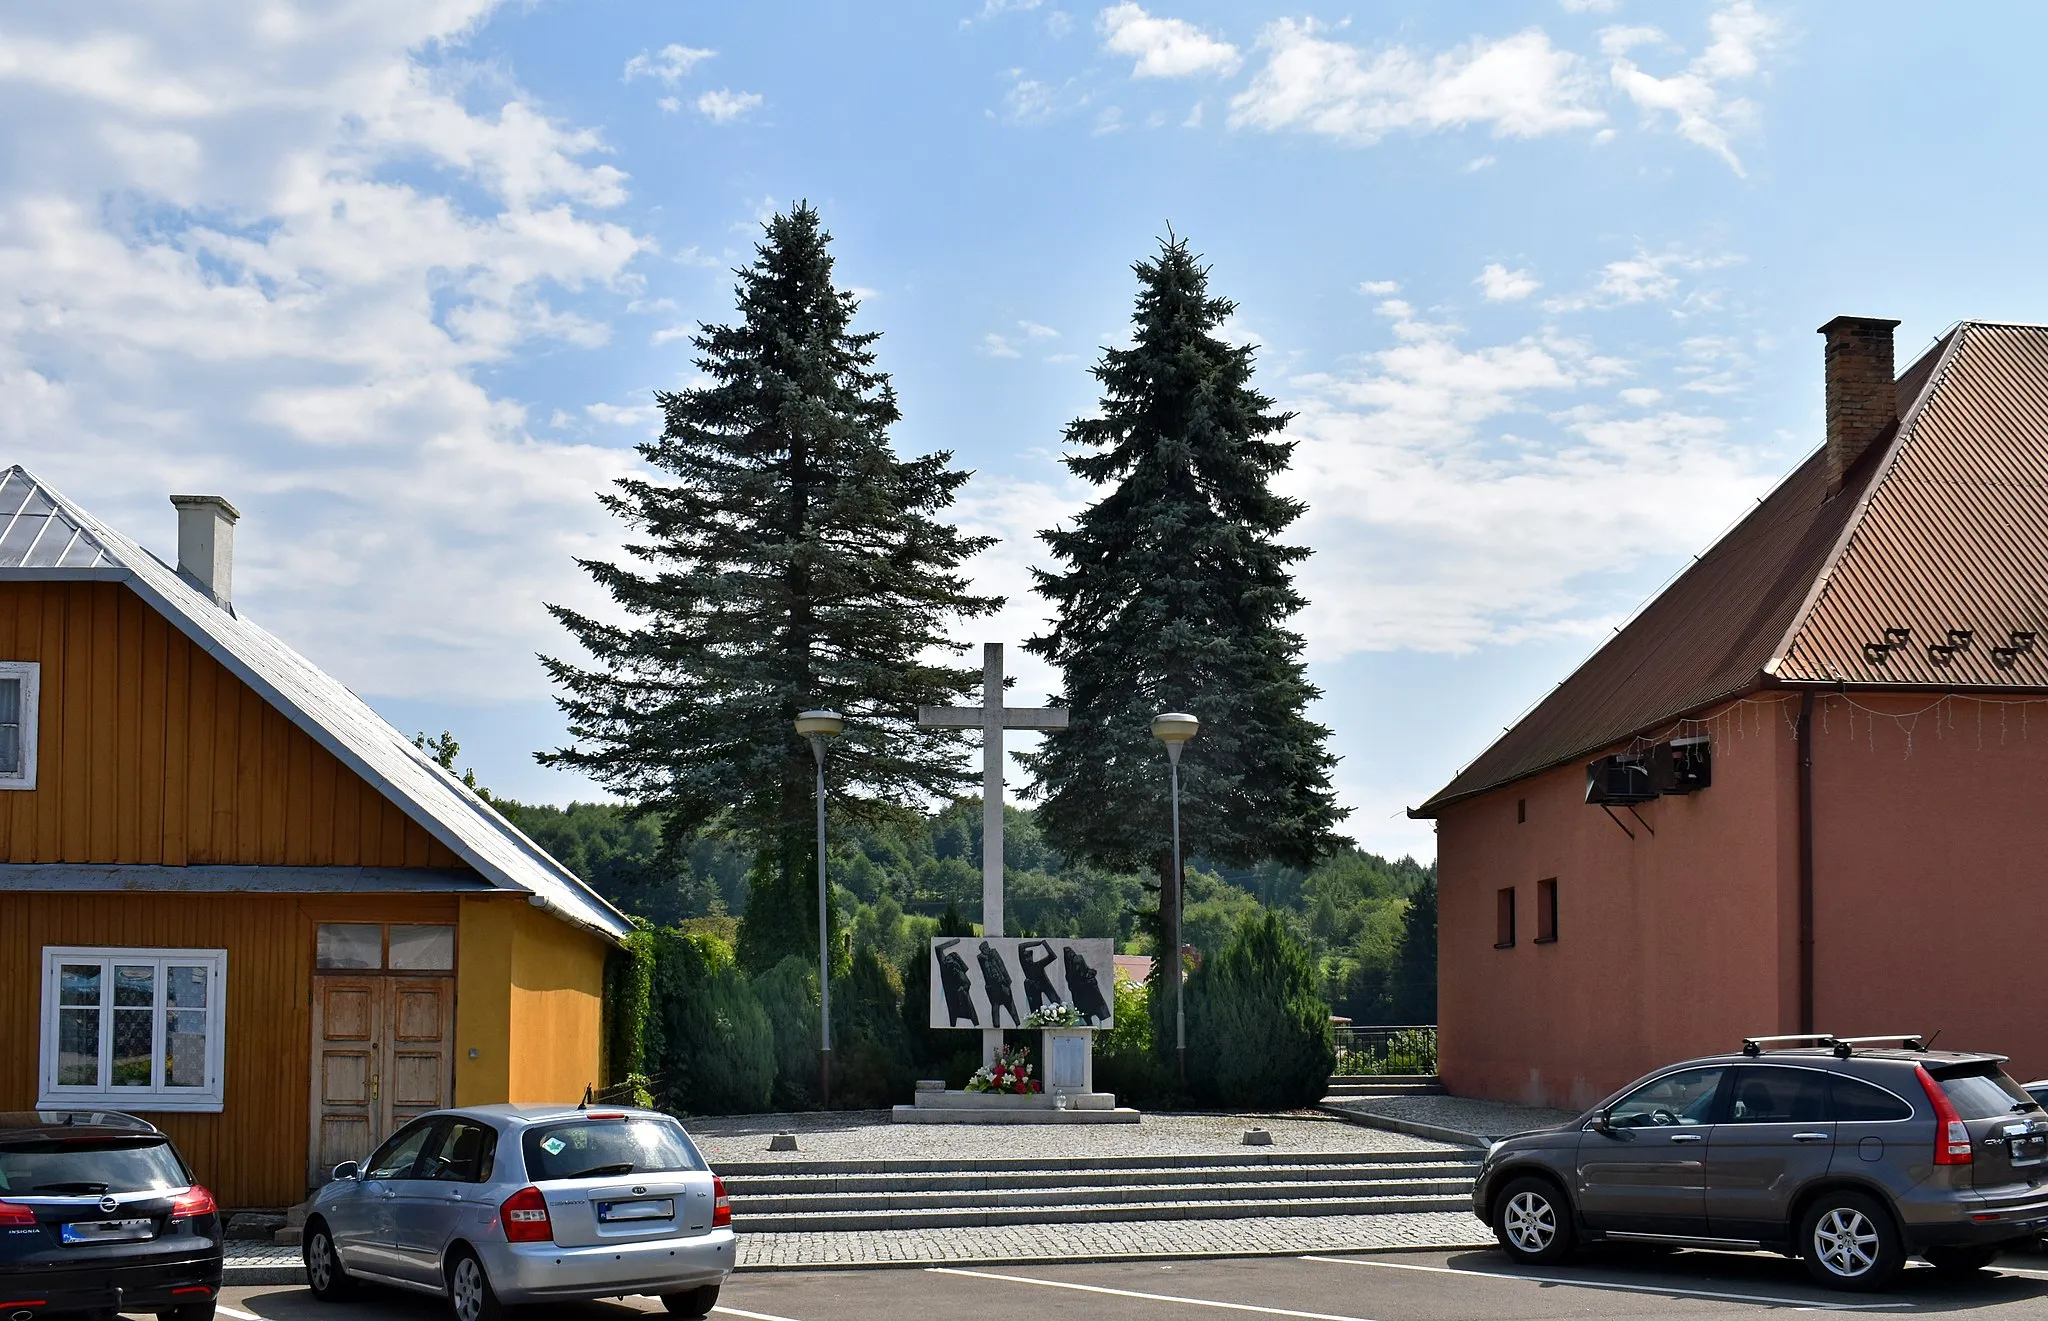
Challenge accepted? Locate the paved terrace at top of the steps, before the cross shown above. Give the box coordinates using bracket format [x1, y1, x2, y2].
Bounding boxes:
[682, 1110, 1462, 1169]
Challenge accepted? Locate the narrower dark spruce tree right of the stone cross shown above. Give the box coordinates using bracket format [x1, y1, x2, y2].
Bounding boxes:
[1026, 236, 1343, 1051]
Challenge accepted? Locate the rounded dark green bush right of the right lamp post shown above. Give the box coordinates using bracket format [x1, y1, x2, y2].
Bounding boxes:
[1188, 911, 1337, 1108]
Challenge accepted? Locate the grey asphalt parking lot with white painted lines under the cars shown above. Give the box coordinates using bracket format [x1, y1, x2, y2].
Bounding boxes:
[155, 1251, 2048, 1321]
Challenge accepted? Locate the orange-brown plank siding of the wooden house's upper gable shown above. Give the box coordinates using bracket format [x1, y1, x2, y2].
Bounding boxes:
[0, 582, 463, 868]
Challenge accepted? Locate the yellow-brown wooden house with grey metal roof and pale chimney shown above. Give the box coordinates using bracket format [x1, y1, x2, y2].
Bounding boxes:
[0, 467, 629, 1206]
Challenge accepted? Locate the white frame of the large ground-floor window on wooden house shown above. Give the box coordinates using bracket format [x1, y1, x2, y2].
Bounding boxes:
[35, 944, 227, 1114]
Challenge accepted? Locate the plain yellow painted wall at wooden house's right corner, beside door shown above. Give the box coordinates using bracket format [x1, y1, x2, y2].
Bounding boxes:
[455, 895, 610, 1106]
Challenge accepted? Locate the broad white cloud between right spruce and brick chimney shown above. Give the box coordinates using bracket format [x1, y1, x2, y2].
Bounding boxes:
[1280, 319, 1774, 659]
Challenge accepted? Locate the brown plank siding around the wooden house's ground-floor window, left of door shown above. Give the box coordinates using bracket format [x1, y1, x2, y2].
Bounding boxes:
[0, 893, 459, 1206]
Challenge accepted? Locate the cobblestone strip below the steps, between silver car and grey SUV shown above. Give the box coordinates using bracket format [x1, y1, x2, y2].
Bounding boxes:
[739, 1210, 1493, 1270]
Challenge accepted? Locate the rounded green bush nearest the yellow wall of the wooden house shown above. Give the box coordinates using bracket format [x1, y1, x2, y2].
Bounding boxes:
[647, 930, 774, 1114]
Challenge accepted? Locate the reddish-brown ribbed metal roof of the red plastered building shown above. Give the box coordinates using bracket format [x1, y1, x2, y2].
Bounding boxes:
[1413, 322, 2048, 817]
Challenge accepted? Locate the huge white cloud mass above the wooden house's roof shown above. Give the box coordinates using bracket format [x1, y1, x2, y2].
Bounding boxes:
[0, 0, 651, 702]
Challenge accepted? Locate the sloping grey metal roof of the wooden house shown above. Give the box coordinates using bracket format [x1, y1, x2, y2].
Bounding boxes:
[0, 465, 633, 936]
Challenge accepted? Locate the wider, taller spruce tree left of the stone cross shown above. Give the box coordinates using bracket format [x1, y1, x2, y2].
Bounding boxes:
[541, 205, 1001, 971]
